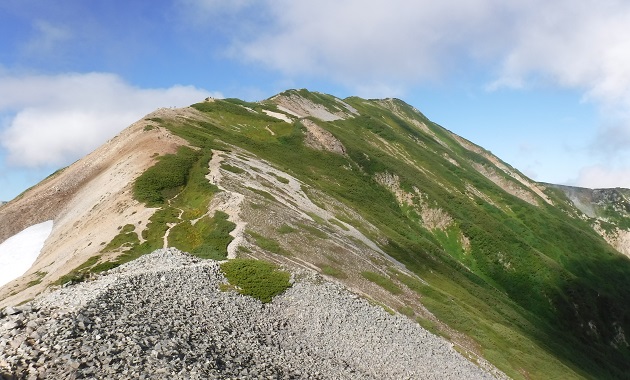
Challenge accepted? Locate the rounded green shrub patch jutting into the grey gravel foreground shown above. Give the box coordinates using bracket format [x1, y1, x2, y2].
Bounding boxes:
[221, 259, 291, 303]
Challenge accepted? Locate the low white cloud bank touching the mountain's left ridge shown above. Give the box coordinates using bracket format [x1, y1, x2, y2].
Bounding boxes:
[0, 73, 221, 167]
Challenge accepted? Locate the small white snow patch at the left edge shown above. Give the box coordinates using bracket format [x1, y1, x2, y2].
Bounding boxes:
[0, 220, 53, 286]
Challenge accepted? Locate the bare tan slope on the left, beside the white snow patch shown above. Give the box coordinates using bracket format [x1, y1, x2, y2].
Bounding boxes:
[0, 110, 187, 304]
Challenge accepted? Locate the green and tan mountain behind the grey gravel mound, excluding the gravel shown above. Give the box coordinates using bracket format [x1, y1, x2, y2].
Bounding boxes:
[0, 90, 630, 379]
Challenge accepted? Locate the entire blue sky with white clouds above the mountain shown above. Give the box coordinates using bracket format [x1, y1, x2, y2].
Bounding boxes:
[0, 0, 630, 200]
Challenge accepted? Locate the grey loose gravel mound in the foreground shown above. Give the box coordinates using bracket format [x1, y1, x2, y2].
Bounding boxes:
[0, 249, 502, 379]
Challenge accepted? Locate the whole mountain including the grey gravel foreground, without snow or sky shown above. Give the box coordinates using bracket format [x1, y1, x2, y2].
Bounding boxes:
[0, 89, 630, 379]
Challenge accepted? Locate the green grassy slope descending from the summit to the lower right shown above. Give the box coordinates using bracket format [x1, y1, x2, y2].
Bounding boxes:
[147, 94, 630, 379]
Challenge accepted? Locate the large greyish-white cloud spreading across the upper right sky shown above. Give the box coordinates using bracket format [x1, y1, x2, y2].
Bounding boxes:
[201, 0, 630, 103]
